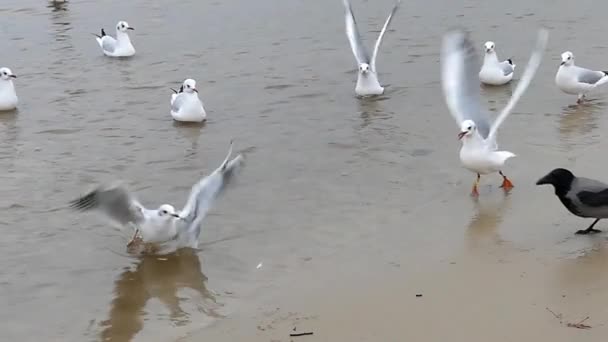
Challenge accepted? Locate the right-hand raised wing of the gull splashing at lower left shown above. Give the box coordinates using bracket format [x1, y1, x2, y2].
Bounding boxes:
[179, 141, 243, 237]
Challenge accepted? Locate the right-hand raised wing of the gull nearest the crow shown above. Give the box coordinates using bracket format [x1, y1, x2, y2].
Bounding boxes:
[488, 29, 549, 143]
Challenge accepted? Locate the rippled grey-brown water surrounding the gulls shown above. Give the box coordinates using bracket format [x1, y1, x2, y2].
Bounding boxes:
[0, 0, 608, 341]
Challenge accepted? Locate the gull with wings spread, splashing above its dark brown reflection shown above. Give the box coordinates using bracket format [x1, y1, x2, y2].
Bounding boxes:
[70, 142, 243, 254]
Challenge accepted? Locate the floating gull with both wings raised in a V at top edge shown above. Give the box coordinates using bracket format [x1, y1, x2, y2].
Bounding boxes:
[343, 0, 401, 96]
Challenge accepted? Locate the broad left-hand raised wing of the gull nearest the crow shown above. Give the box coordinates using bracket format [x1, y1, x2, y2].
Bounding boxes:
[441, 31, 490, 138]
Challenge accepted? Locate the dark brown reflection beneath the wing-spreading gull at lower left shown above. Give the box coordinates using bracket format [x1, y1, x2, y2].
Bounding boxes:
[101, 249, 221, 342]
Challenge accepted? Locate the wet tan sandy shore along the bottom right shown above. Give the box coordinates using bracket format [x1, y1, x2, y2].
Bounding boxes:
[179, 231, 608, 342]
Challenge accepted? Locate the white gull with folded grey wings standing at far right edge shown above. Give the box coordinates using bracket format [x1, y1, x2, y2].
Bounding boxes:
[555, 51, 608, 103]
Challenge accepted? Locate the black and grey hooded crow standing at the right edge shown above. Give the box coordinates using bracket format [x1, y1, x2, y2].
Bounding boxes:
[536, 168, 608, 234]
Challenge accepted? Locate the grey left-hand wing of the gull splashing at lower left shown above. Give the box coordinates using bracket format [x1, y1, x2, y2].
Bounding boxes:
[70, 184, 145, 225]
